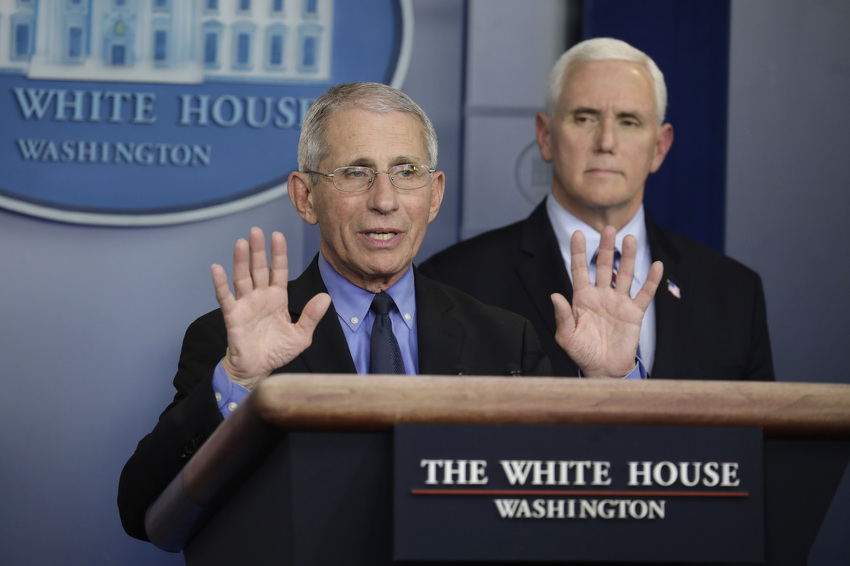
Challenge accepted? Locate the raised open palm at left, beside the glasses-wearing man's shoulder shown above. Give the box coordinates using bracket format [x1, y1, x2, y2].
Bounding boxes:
[212, 227, 331, 389]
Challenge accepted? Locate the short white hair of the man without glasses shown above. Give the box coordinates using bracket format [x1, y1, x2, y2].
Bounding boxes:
[546, 37, 667, 126]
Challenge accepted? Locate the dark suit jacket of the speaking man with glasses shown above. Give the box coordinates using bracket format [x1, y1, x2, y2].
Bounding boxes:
[118, 256, 551, 540]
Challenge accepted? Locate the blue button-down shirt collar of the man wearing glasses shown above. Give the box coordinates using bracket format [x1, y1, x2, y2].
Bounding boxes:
[319, 253, 416, 332]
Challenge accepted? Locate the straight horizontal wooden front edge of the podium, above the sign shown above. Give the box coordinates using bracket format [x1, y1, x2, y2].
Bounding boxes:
[248, 374, 850, 438]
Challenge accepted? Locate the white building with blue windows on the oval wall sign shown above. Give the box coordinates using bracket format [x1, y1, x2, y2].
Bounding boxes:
[0, 0, 333, 83]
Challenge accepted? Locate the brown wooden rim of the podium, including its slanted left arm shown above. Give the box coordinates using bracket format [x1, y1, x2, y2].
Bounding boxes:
[146, 374, 850, 551]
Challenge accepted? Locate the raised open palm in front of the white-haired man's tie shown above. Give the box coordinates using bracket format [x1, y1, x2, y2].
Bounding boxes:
[552, 226, 664, 378]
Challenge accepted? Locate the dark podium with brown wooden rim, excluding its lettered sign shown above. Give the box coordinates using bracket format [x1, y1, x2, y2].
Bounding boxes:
[146, 374, 850, 566]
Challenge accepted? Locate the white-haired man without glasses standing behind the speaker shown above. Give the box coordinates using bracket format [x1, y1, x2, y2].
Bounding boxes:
[420, 38, 774, 380]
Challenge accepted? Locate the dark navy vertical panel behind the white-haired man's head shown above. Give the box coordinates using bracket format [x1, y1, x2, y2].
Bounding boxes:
[582, 0, 730, 251]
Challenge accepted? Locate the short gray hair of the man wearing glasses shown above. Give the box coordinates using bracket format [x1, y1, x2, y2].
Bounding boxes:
[298, 82, 437, 182]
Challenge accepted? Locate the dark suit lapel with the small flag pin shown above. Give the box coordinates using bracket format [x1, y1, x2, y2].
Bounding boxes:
[646, 214, 694, 379]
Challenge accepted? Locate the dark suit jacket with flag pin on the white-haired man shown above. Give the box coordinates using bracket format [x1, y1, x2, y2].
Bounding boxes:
[419, 201, 774, 380]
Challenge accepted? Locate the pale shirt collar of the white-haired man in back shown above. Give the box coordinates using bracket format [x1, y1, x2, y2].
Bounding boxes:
[546, 193, 652, 283]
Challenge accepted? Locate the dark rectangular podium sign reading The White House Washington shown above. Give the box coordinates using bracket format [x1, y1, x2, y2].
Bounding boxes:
[394, 425, 764, 562]
